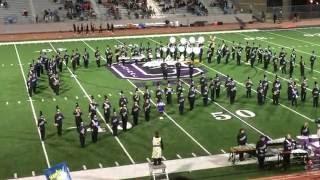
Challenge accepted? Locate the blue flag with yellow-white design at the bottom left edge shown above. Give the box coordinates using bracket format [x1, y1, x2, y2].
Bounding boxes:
[44, 163, 71, 180]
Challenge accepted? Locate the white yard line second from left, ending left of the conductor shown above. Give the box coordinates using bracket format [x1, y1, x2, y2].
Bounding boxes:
[49, 42, 135, 164]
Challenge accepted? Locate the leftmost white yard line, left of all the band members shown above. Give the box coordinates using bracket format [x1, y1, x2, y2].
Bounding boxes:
[14, 45, 51, 168]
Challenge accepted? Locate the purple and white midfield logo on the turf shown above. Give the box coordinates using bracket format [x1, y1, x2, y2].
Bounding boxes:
[110, 61, 203, 80]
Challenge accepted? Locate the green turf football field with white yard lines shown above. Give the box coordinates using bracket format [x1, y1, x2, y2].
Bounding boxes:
[0, 28, 320, 179]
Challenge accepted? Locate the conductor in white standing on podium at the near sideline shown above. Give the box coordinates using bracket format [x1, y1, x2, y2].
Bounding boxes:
[152, 131, 163, 166]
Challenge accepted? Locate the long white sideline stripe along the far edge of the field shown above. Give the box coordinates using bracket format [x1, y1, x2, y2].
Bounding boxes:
[0, 29, 260, 46]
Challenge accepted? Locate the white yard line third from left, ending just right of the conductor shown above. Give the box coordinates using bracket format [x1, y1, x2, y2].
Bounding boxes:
[83, 40, 211, 155]
